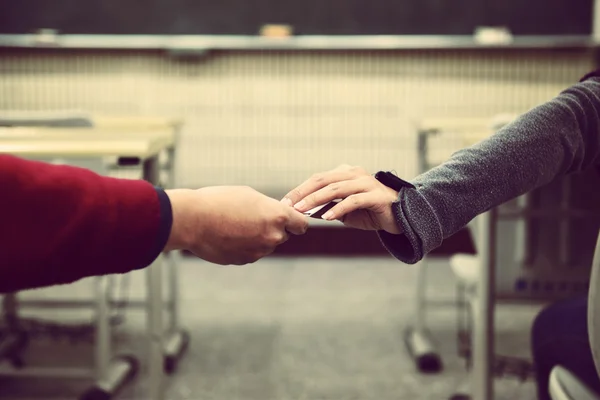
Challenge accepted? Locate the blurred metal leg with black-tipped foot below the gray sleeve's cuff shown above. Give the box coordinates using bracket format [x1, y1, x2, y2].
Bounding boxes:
[404, 260, 443, 373]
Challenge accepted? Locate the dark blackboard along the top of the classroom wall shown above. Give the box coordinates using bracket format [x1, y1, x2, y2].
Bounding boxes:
[0, 0, 593, 35]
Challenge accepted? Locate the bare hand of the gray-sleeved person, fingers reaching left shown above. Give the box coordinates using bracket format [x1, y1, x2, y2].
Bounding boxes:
[282, 165, 402, 234]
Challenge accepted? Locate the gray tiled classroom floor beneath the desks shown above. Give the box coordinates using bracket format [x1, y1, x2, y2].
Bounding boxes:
[0, 257, 535, 400]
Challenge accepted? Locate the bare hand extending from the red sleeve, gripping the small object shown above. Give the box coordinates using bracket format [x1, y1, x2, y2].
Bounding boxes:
[165, 186, 308, 265]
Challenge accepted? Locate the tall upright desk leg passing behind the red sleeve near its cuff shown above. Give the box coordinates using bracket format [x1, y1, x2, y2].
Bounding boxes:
[144, 156, 164, 400]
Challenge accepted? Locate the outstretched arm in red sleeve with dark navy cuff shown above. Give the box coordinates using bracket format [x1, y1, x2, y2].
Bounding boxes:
[0, 155, 172, 293]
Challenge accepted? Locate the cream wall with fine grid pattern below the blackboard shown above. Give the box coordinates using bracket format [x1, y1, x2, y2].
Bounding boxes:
[0, 51, 592, 194]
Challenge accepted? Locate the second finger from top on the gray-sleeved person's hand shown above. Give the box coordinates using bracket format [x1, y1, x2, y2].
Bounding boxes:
[294, 176, 376, 212]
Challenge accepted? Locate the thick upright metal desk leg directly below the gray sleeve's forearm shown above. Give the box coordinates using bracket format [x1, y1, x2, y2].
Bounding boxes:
[472, 209, 497, 400]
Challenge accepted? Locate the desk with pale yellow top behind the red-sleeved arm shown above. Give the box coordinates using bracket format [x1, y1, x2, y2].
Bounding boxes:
[0, 128, 174, 400]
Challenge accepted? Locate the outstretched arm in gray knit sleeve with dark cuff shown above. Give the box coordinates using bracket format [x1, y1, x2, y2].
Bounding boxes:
[379, 77, 600, 264]
